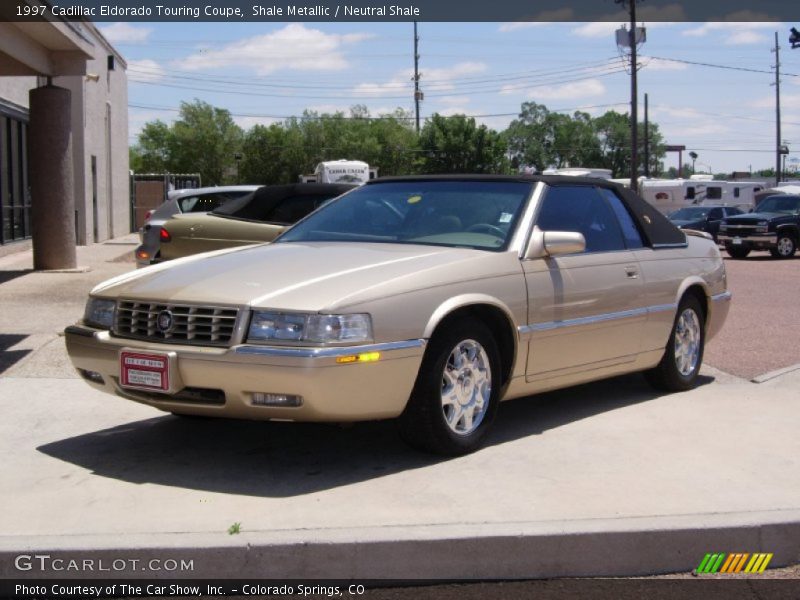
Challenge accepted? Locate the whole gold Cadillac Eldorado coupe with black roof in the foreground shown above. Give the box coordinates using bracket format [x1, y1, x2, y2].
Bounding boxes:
[66, 176, 731, 454]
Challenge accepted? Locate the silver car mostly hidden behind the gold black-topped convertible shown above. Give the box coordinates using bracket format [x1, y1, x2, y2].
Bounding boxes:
[134, 185, 259, 267]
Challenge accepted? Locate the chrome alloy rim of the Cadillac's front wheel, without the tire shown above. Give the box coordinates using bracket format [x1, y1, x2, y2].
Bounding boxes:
[442, 340, 492, 435]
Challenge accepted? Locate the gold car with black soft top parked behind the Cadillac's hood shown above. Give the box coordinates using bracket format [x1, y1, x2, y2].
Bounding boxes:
[161, 183, 356, 260]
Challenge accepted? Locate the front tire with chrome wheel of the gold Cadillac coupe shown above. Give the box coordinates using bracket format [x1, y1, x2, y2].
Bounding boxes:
[398, 318, 500, 456]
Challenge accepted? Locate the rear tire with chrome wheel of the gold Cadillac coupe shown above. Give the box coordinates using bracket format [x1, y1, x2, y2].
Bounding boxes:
[645, 296, 706, 392]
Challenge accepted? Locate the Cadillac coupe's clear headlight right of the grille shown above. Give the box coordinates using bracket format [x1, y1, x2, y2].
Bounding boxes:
[247, 310, 372, 344]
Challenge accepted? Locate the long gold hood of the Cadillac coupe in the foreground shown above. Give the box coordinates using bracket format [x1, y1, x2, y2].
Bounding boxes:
[92, 242, 520, 311]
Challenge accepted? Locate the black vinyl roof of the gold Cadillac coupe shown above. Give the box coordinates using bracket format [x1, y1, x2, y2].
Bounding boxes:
[365, 175, 686, 248]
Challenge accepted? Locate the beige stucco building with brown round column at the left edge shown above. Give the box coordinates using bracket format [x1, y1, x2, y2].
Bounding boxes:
[0, 13, 131, 268]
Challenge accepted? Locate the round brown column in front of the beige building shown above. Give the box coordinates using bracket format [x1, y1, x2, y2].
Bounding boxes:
[28, 85, 78, 270]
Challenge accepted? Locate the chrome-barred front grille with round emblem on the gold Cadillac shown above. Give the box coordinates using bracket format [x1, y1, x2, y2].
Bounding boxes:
[114, 300, 238, 346]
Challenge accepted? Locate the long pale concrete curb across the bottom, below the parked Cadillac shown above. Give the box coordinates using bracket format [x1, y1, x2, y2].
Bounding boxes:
[0, 510, 800, 581]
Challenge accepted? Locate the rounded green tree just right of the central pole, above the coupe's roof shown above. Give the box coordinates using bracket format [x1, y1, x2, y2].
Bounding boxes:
[419, 114, 509, 173]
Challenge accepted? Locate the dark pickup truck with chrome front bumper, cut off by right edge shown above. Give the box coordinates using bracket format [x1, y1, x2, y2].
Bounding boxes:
[719, 195, 800, 258]
